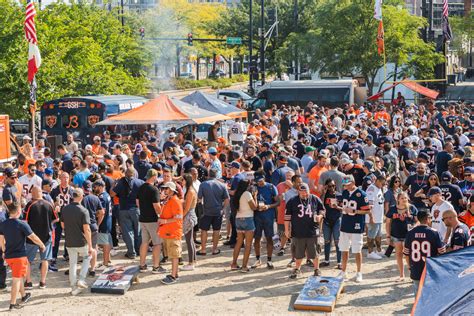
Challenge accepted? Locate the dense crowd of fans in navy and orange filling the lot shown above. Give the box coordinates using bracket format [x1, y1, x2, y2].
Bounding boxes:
[0, 98, 474, 309]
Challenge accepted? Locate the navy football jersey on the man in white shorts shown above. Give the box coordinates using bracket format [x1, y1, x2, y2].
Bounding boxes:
[341, 188, 369, 234]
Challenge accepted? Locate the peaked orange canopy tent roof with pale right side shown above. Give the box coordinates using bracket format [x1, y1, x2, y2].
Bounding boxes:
[97, 95, 231, 125]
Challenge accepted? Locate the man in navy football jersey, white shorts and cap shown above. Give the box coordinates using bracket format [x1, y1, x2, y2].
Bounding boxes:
[339, 175, 370, 282]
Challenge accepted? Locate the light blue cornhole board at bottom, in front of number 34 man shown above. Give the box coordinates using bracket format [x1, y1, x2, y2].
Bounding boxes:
[293, 276, 344, 312]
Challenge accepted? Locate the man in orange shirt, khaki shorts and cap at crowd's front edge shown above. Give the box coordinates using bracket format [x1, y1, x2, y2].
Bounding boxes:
[157, 182, 183, 285]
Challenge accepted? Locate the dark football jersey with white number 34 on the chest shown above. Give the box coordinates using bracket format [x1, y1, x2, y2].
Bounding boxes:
[285, 194, 325, 238]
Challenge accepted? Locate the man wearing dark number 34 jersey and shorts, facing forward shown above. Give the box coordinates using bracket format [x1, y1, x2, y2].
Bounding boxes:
[285, 183, 325, 279]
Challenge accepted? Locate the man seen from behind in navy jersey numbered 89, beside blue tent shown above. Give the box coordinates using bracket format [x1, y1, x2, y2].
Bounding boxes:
[403, 211, 446, 297]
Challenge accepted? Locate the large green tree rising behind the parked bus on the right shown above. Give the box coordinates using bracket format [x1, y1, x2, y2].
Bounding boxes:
[278, 0, 442, 94]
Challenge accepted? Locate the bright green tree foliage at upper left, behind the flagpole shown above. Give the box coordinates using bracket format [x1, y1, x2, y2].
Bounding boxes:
[0, 0, 150, 118]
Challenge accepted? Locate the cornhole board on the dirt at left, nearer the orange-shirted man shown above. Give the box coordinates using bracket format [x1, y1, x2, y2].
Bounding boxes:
[91, 265, 140, 295]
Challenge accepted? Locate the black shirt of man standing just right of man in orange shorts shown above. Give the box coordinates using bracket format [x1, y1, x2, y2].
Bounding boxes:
[24, 200, 56, 244]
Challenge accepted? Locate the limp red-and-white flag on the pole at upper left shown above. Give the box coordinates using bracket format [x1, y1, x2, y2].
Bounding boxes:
[25, 0, 41, 84]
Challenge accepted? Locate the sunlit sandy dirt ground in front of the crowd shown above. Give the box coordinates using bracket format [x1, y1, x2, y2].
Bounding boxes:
[0, 237, 414, 315]
